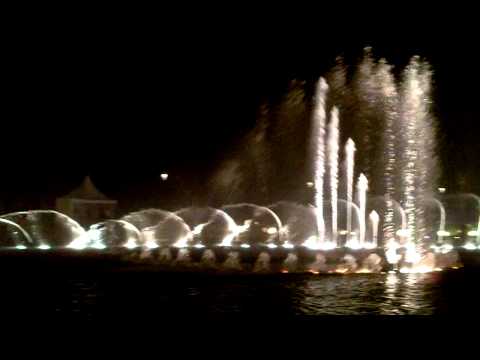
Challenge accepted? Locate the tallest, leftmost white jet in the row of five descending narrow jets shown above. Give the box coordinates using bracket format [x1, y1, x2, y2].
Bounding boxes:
[312, 78, 328, 246]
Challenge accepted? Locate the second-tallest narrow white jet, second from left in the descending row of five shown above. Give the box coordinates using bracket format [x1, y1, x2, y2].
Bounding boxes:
[328, 107, 340, 246]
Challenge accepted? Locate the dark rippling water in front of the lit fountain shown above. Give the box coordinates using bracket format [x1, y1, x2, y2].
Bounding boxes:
[0, 269, 480, 319]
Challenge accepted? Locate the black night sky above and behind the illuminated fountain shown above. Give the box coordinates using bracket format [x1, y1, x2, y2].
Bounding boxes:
[0, 11, 480, 211]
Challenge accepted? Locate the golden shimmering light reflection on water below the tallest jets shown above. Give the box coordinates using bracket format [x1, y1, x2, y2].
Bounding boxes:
[295, 273, 435, 315]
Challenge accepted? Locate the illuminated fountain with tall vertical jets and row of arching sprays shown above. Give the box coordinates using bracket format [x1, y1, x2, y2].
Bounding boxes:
[0, 50, 464, 273]
